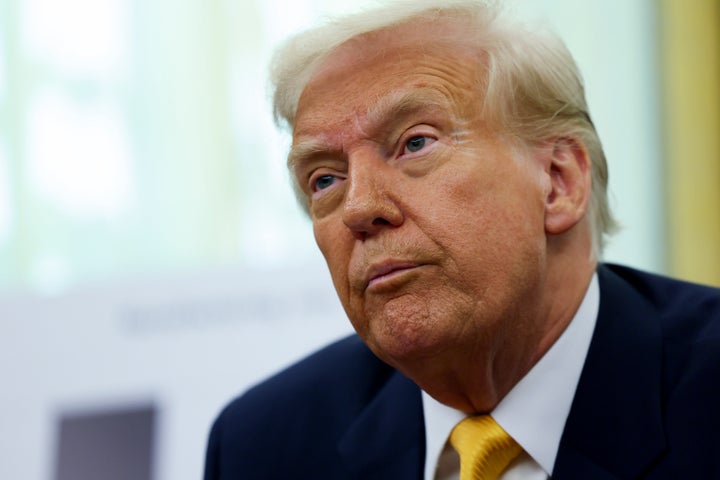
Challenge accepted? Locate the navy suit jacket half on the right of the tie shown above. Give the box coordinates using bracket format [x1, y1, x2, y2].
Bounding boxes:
[553, 265, 720, 480]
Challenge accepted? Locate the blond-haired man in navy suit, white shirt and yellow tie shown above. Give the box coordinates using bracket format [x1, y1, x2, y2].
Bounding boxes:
[205, 1, 720, 480]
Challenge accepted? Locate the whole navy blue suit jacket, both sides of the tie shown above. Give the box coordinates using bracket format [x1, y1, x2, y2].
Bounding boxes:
[205, 266, 720, 480]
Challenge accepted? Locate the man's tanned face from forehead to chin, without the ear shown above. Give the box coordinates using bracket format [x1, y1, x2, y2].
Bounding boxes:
[291, 23, 549, 394]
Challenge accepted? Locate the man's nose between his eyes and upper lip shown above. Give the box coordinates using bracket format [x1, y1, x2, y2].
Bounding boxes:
[342, 157, 404, 240]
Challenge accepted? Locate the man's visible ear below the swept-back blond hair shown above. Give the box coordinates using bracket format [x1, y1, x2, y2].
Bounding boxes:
[545, 137, 591, 235]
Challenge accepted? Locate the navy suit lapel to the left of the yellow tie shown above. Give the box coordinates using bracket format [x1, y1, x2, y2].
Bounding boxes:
[338, 372, 425, 480]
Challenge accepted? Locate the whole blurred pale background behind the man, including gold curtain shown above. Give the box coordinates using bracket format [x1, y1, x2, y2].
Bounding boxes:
[0, 0, 720, 480]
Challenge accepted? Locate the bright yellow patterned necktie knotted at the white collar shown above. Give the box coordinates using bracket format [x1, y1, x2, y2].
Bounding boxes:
[450, 415, 522, 480]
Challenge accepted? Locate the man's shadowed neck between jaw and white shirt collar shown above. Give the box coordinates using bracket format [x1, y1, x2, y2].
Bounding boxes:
[410, 231, 596, 413]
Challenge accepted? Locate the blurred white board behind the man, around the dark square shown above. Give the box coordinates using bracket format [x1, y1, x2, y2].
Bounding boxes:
[0, 263, 350, 480]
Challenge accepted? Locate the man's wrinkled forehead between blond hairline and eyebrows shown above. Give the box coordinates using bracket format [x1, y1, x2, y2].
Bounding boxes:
[294, 20, 484, 139]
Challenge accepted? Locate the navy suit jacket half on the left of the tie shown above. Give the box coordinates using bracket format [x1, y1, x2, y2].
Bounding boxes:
[205, 335, 424, 480]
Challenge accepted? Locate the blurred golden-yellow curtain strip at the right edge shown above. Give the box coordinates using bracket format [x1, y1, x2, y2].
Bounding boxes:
[659, 0, 720, 285]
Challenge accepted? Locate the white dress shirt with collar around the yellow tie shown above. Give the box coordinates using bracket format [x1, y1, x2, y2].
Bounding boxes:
[422, 274, 600, 480]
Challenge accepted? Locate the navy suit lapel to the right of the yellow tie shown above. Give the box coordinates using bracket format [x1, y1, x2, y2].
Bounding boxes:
[553, 266, 665, 480]
